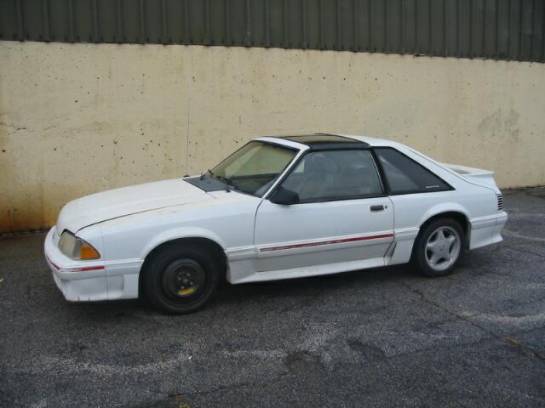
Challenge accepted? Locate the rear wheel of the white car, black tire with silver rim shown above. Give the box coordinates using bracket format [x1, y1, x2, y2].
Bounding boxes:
[411, 218, 465, 277]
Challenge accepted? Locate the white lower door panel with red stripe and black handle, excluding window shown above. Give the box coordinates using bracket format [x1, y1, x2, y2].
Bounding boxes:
[255, 197, 393, 273]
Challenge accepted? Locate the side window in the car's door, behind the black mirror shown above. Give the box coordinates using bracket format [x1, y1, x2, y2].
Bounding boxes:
[282, 149, 383, 203]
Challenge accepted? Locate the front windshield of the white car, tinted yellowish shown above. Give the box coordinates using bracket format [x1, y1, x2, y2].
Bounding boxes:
[208, 141, 297, 197]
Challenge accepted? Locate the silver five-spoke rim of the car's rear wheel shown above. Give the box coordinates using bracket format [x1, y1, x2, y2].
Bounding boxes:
[425, 226, 461, 271]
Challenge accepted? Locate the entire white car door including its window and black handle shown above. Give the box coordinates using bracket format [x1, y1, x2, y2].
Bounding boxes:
[254, 148, 394, 272]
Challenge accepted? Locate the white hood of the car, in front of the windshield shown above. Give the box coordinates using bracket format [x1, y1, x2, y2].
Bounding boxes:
[57, 179, 210, 234]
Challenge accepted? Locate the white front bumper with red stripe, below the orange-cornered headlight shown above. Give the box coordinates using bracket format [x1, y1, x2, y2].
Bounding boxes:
[44, 227, 142, 302]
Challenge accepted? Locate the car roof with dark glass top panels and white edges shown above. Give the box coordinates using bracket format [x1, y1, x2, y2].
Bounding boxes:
[257, 133, 396, 150]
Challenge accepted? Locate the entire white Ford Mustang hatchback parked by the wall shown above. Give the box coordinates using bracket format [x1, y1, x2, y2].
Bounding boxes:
[45, 134, 507, 313]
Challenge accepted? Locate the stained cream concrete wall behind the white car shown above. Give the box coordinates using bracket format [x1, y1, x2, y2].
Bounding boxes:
[0, 42, 545, 231]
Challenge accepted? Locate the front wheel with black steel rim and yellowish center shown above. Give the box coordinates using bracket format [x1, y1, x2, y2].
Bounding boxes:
[142, 243, 223, 314]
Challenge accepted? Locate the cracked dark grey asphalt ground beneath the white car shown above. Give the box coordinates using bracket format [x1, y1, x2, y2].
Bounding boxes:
[0, 188, 545, 408]
